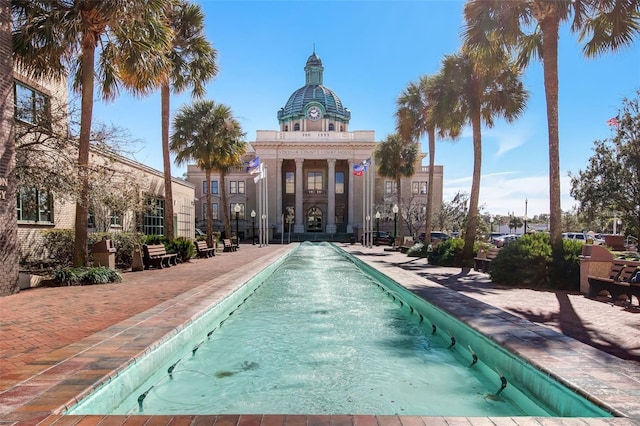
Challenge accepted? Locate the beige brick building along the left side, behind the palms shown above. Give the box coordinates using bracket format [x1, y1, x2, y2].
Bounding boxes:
[5, 51, 195, 296]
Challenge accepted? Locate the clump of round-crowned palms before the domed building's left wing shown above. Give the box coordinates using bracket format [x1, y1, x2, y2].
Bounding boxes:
[169, 100, 247, 247]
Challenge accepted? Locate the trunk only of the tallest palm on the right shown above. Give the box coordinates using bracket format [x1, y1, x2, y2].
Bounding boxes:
[540, 19, 563, 257]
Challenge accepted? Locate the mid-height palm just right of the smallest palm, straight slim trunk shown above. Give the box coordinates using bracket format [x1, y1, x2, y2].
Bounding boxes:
[396, 75, 462, 250]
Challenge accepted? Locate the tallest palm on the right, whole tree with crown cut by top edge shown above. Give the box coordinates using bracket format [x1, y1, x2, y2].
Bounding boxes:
[464, 0, 640, 257]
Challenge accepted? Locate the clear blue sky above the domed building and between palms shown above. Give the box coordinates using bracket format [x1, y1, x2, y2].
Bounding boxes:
[94, 0, 640, 217]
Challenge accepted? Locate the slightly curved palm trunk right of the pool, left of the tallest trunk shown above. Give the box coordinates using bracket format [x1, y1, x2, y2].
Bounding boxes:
[462, 107, 482, 266]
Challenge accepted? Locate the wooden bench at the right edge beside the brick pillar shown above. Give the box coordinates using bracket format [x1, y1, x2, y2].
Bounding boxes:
[587, 259, 640, 305]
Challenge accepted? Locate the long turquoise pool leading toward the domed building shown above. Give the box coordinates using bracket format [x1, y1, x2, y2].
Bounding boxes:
[68, 243, 607, 416]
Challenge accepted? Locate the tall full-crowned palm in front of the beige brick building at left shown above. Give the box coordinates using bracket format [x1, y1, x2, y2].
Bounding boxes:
[11, 0, 171, 266]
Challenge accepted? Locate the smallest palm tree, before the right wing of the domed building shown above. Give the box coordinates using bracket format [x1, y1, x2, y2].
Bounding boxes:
[373, 133, 418, 237]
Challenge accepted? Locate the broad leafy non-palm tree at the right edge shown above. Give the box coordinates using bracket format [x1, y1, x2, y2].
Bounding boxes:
[570, 90, 640, 237]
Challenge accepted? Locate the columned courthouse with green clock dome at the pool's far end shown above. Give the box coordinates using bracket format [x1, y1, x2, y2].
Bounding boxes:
[187, 50, 442, 242]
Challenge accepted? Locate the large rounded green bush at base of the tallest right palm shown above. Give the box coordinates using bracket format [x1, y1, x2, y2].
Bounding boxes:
[489, 233, 582, 290]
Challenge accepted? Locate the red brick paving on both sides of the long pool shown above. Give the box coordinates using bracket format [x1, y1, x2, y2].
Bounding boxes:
[0, 244, 640, 426]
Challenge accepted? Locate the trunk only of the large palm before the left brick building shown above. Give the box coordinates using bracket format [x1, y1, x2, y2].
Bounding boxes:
[73, 40, 96, 267]
